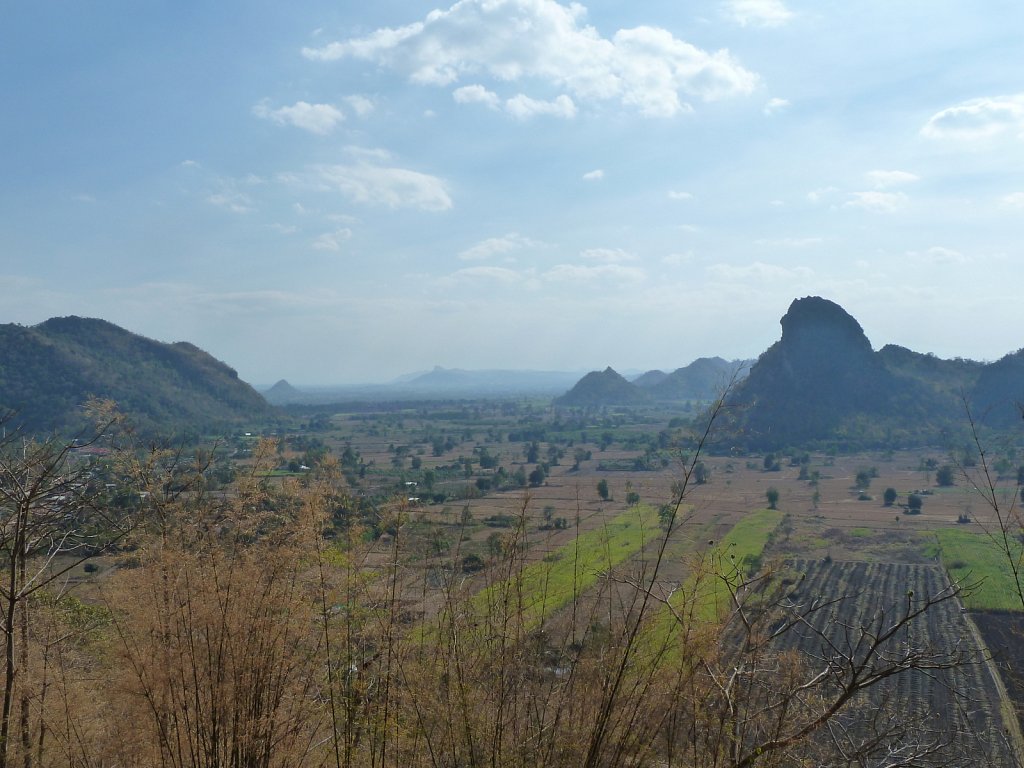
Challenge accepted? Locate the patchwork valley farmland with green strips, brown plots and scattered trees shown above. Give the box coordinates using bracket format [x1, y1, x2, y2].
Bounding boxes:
[270, 401, 1024, 765]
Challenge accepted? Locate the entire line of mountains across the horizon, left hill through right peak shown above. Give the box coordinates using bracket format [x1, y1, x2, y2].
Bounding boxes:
[8, 303, 1024, 450]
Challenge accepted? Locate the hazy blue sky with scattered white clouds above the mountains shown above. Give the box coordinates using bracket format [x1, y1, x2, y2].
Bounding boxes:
[0, 0, 1024, 385]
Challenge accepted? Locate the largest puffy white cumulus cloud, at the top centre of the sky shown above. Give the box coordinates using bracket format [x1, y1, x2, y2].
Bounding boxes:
[302, 0, 757, 117]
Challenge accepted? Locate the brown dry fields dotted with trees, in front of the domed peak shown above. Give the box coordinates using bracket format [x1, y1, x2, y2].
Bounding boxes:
[399, 450, 988, 562]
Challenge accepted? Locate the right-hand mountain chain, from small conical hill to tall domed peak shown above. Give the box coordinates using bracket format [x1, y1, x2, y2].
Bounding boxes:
[556, 296, 1024, 449]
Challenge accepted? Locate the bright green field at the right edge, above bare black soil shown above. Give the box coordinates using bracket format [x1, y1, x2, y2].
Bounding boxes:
[935, 528, 1024, 610]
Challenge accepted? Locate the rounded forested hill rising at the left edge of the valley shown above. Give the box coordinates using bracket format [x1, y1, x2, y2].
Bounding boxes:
[0, 316, 270, 433]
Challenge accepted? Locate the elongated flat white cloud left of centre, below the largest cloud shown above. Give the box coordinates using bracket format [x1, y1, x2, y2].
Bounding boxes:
[312, 152, 452, 211]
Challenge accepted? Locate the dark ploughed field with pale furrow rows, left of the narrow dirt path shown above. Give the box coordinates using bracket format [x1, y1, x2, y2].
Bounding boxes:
[779, 560, 1013, 765]
